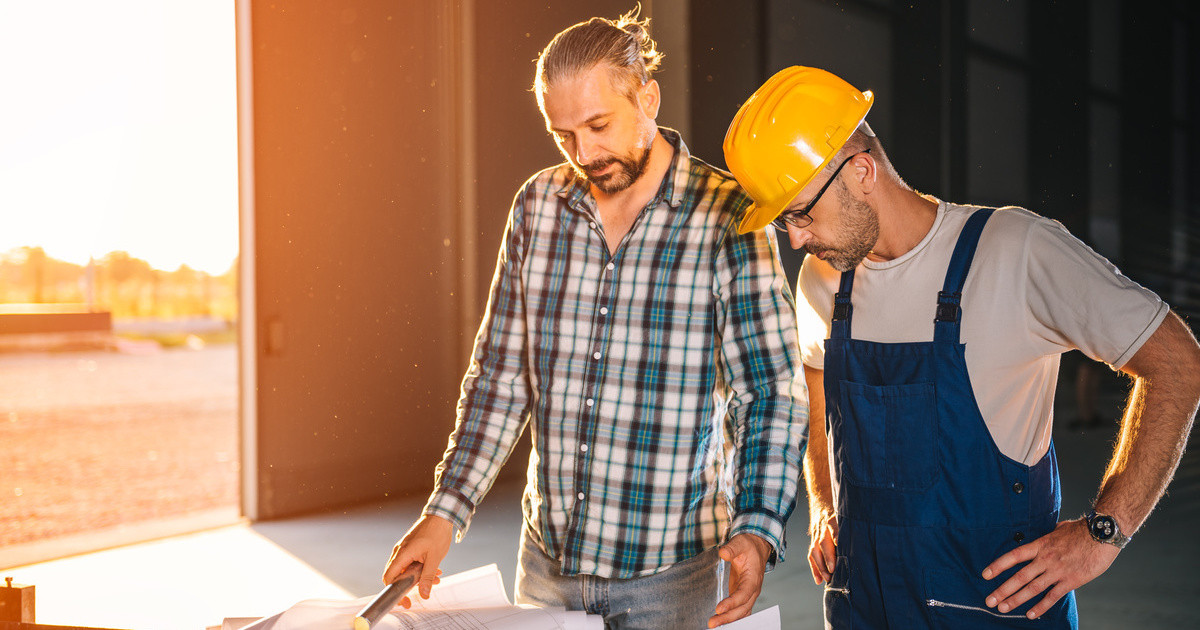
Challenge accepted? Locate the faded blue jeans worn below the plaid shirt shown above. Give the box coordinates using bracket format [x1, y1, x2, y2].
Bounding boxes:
[514, 528, 726, 630]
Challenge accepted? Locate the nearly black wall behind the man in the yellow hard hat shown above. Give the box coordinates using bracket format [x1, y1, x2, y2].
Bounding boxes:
[689, 0, 1200, 307]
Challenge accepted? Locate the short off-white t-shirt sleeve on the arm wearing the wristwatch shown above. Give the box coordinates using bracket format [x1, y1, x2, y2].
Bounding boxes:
[1025, 218, 1169, 370]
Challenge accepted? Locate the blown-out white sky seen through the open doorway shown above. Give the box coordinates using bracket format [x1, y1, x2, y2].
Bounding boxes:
[0, 0, 238, 275]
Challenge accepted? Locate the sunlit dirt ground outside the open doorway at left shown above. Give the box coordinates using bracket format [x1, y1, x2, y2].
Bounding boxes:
[0, 344, 238, 547]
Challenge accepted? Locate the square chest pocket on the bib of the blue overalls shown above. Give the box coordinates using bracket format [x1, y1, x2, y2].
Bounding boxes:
[836, 380, 940, 491]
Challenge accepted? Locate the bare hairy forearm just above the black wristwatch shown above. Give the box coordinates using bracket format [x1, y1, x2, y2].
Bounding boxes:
[1096, 313, 1200, 534]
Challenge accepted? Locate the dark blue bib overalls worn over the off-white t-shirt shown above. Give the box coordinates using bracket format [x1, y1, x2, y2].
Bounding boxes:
[824, 209, 1078, 630]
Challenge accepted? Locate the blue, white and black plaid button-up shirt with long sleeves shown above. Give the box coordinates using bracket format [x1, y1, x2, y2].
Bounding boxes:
[425, 128, 808, 578]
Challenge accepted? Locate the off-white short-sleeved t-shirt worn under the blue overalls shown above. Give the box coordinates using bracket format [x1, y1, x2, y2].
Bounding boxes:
[797, 202, 1169, 466]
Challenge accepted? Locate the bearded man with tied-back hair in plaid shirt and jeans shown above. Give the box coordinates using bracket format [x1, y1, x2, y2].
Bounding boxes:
[384, 16, 808, 628]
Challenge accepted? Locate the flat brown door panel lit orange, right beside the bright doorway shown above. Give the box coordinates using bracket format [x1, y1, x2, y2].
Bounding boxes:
[252, 0, 462, 518]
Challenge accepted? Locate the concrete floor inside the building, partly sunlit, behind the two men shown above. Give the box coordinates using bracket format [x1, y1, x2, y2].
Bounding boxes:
[4, 364, 1200, 630]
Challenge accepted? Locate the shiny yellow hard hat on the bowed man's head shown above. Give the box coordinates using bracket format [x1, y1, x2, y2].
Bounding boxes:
[725, 66, 875, 234]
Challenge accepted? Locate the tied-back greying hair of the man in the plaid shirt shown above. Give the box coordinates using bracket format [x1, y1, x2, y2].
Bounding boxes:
[533, 6, 662, 106]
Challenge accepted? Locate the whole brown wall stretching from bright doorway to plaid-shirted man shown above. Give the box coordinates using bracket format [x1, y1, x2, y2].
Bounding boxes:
[244, 0, 631, 518]
